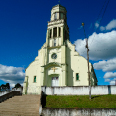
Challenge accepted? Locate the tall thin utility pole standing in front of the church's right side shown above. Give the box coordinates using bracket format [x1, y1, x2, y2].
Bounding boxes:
[82, 23, 91, 100]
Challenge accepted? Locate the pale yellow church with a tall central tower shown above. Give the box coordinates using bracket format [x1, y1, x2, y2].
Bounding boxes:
[23, 4, 98, 94]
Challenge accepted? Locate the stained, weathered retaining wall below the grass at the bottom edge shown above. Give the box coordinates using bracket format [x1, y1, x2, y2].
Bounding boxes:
[42, 108, 116, 116]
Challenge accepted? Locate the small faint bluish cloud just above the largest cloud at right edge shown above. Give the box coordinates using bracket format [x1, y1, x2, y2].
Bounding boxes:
[100, 19, 116, 31]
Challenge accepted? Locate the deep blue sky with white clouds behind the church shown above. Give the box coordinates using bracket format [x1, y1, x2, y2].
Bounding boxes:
[0, 0, 116, 87]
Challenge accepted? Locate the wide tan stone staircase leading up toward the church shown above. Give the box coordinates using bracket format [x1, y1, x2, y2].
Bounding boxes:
[0, 95, 40, 116]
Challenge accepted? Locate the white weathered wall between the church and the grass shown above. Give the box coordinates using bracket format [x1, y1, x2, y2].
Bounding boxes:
[41, 85, 116, 95]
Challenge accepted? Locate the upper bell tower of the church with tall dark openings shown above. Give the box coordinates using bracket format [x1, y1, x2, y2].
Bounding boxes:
[46, 4, 69, 47]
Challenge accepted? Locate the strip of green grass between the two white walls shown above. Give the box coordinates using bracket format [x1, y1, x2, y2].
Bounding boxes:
[45, 95, 116, 108]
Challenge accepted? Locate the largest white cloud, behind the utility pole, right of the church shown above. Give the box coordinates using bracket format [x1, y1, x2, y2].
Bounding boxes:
[74, 30, 116, 61]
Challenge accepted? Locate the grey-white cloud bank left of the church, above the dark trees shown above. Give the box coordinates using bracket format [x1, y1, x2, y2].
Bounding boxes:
[0, 64, 25, 88]
